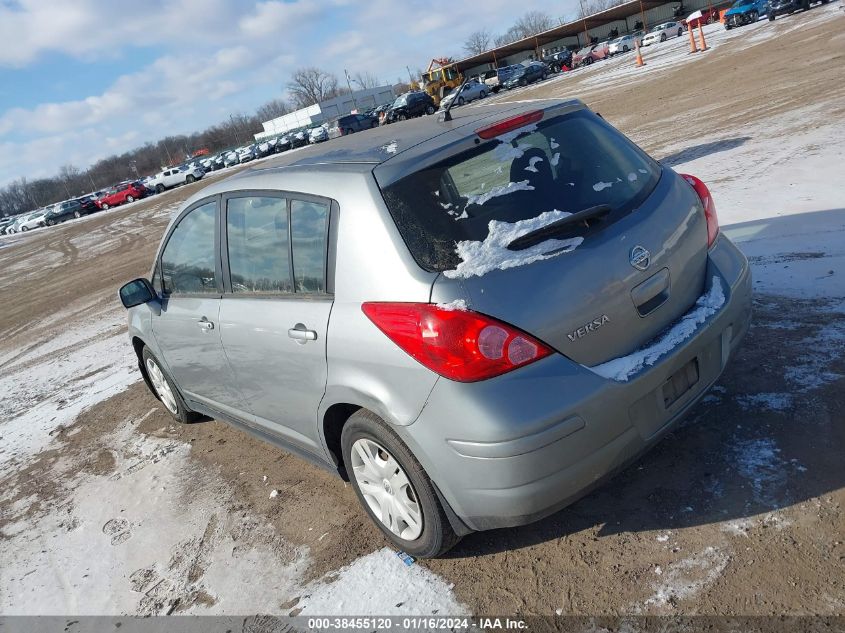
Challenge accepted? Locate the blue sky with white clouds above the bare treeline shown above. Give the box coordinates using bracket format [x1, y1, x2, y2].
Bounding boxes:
[0, 0, 577, 187]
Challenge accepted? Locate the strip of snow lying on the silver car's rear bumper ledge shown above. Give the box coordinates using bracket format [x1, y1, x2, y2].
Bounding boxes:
[589, 277, 725, 382]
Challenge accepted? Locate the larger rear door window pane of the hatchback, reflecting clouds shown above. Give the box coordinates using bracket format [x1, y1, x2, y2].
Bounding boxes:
[226, 196, 293, 294]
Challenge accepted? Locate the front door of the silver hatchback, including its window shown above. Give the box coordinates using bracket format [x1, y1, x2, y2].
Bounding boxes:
[152, 197, 243, 414]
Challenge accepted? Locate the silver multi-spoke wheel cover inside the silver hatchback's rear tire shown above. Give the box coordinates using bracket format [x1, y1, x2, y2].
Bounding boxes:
[352, 438, 423, 541]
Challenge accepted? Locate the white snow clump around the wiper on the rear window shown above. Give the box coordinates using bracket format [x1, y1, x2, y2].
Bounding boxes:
[443, 209, 584, 279]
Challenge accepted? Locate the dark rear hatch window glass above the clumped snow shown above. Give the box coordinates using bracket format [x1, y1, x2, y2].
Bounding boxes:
[382, 110, 660, 272]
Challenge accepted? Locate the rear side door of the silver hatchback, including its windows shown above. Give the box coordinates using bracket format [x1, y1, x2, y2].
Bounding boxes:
[220, 191, 333, 457]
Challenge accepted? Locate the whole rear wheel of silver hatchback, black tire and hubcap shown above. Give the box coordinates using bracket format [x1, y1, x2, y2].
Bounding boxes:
[340, 409, 460, 558]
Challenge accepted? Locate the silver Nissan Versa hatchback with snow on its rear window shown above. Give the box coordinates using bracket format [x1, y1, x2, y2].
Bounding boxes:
[120, 101, 751, 556]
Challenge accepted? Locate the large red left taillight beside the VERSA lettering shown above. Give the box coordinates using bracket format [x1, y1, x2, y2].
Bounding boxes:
[361, 303, 552, 382]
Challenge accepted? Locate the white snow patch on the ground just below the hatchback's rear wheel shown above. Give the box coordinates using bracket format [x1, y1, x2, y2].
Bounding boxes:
[297, 547, 468, 616]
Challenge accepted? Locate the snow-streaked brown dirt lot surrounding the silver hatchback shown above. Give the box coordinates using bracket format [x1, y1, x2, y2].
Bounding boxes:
[0, 2, 845, 615]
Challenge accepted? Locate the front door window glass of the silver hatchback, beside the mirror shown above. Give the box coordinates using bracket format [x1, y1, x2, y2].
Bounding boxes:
[161, 202, 217, 294]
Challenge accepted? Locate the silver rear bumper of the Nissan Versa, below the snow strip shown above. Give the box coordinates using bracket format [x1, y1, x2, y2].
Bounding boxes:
[396, 236, 751, 530]
